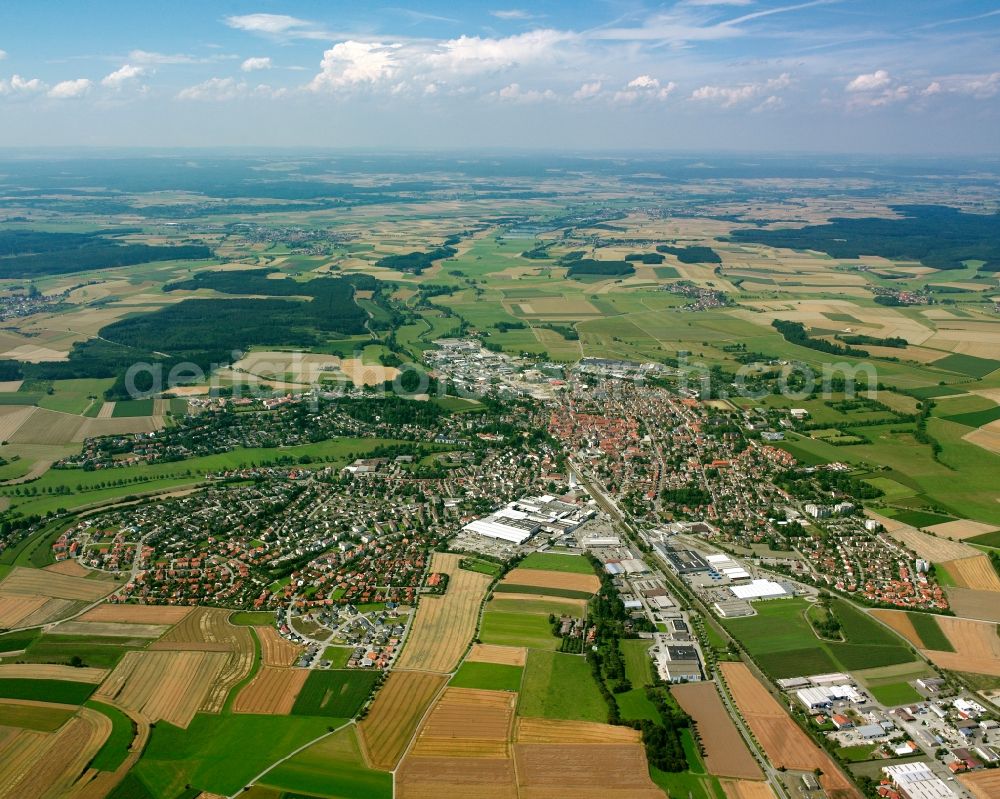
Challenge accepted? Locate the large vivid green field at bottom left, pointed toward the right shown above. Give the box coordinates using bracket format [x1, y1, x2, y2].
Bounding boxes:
[125, 713, 332, 799]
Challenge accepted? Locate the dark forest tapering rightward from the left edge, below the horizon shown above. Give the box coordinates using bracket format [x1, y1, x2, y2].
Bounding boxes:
[0, 230, 212, 278]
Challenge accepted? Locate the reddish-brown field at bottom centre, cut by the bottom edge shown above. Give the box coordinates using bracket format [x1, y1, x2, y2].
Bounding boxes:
[514, 743, 663, 799]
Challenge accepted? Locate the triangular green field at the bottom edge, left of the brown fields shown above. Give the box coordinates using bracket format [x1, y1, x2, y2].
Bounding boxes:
[260, 727, 392, 799]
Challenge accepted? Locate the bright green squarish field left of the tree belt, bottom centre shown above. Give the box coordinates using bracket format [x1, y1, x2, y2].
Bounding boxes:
[517, 649, 608, 722]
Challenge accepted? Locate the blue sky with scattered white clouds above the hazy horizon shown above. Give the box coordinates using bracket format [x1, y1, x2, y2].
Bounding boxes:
[0, 0, 1000, 155]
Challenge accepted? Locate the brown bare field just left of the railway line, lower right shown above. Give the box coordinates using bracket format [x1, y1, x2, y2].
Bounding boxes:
[670, 682, 764, 780]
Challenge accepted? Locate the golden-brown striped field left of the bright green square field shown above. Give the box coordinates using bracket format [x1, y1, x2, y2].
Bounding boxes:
[410, 688, 517, 758]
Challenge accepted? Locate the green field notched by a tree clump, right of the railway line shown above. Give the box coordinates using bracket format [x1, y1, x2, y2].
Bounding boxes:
[722, 599, 913, 679]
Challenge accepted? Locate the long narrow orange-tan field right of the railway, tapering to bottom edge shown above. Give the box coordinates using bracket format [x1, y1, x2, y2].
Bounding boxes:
[719, 663, 861, 799]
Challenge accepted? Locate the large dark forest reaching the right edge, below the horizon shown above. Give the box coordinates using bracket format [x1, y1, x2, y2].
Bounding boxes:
[730, 205, 1000, 272]
